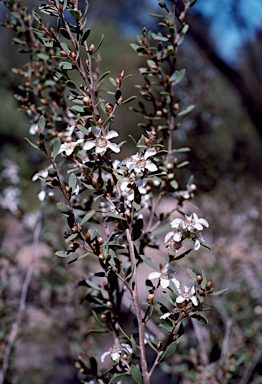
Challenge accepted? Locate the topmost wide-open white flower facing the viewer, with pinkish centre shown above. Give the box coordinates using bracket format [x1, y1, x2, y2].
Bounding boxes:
[84, 127, 120, 154]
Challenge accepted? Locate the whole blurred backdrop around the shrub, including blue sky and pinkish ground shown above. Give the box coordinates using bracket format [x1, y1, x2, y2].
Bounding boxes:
[0, 0, 262, 384]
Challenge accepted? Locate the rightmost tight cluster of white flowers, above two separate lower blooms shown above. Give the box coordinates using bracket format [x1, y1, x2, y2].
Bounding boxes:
[165, 213, 209, 251]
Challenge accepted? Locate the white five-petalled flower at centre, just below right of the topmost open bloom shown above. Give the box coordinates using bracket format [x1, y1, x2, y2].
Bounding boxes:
[126, 148, 157, 173]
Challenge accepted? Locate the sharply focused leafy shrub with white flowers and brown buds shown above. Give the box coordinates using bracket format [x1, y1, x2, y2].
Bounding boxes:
[0, 0, 242, 384]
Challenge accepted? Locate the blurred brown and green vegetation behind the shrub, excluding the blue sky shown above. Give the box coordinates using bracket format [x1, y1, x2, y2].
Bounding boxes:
[0, 0, 262, 384]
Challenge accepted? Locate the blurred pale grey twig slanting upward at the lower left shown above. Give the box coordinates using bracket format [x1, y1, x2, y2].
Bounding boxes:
[0, 204, 44, 384]
